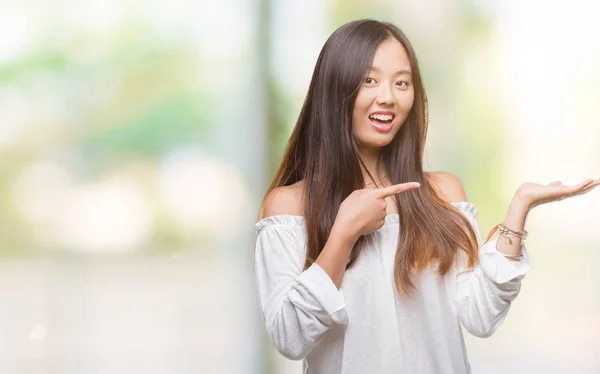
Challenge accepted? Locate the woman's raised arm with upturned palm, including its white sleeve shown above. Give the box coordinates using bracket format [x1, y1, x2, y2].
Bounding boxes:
[453, 179, 600, 337]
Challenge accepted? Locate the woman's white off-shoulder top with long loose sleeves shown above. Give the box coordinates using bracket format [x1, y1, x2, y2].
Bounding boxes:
[255, 201, 530, 374]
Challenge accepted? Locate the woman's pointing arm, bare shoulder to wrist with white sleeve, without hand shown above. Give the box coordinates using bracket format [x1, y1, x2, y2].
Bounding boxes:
[255, 187, 356, 360]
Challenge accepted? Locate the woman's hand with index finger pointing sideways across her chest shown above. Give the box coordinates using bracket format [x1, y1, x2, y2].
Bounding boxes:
[335, 182, 421, 239]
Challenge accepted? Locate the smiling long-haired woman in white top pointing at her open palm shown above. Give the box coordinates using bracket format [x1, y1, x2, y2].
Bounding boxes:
[255, 20, 600, 374]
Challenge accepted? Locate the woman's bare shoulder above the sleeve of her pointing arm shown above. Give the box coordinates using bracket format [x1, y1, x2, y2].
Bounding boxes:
[258, 181, 304, 220]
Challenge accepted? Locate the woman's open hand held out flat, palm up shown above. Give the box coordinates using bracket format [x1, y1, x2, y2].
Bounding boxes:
[517, 179, 600, 209]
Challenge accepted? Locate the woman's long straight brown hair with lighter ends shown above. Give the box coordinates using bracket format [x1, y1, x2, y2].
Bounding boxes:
[267, 20, 478, 294]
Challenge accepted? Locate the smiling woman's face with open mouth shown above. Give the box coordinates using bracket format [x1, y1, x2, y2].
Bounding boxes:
[352, 38, 414, 150]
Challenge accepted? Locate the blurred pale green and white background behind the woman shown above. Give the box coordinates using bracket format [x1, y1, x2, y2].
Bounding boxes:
[0, 0, 600, 374]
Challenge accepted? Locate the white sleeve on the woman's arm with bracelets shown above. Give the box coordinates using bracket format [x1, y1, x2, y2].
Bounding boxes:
[453, 202, 531, 338]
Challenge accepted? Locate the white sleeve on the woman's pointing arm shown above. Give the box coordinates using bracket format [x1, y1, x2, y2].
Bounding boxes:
[255, 216, 348, 360]
